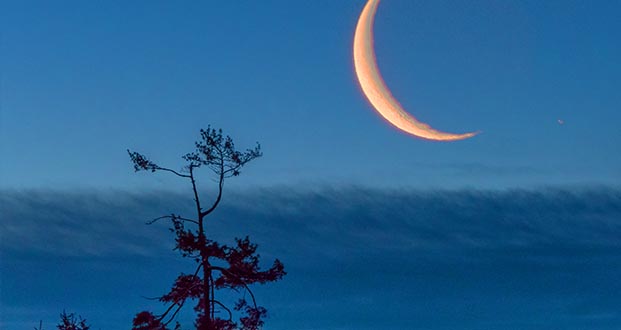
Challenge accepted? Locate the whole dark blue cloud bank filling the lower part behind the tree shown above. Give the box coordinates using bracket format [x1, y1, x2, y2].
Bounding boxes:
[0, 187, 621, 330]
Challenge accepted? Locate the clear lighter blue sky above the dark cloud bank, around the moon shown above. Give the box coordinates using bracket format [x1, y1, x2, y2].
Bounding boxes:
[2, 0, 621, 188]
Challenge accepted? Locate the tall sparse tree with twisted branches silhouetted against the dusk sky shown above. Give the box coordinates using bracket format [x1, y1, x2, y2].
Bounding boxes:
[127, 127, 286, 330]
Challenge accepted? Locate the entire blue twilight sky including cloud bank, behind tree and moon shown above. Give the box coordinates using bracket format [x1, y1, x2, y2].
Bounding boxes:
[0, 0, 621, 330]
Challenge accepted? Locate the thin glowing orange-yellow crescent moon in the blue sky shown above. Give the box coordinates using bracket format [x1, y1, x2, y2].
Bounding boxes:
[354, 0, 477, 141]
